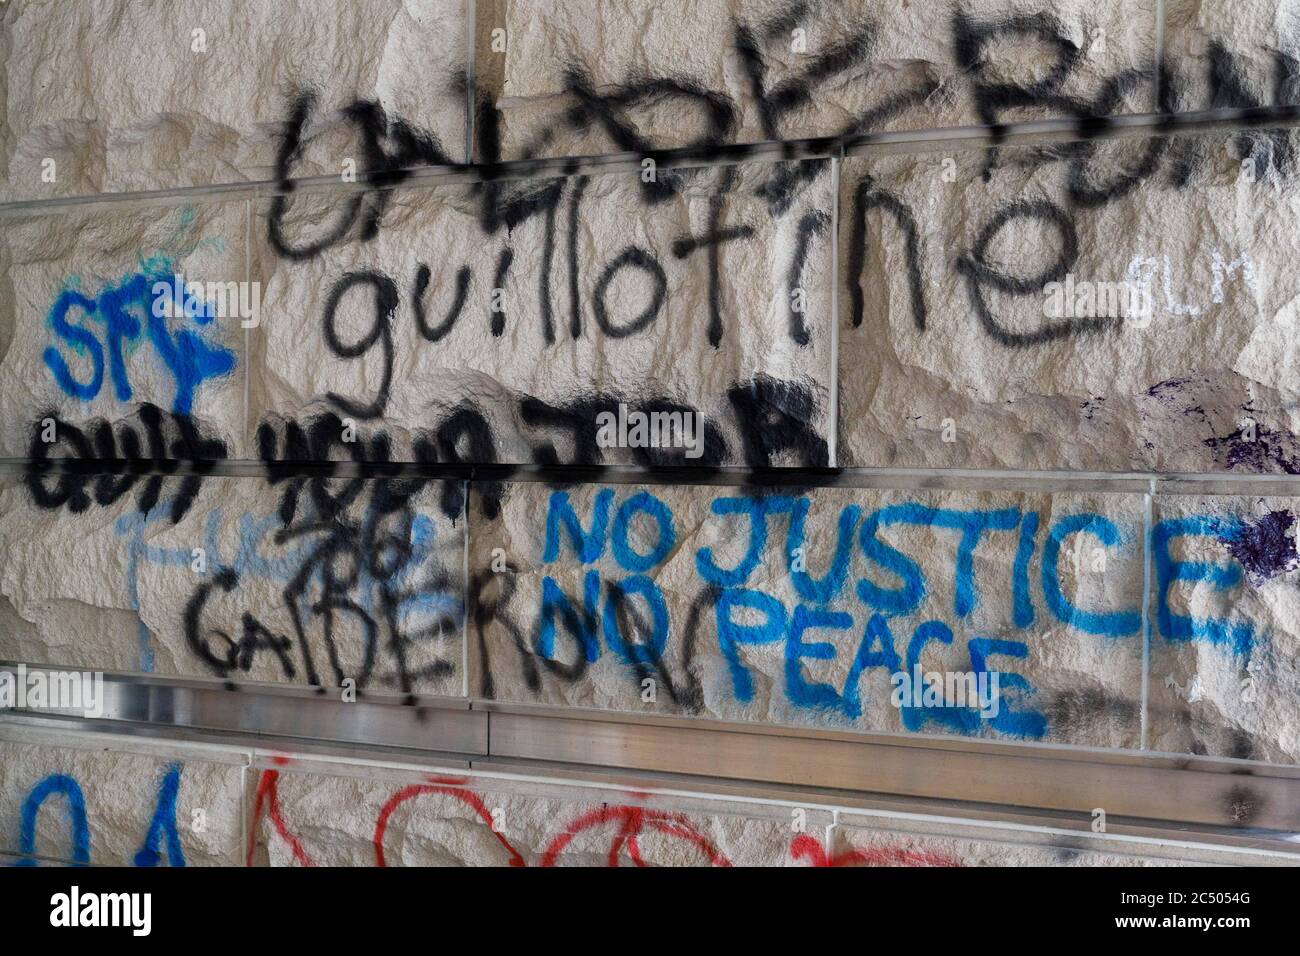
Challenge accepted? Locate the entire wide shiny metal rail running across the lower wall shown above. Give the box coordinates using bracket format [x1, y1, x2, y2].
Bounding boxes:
[0, 662, 1300, 861]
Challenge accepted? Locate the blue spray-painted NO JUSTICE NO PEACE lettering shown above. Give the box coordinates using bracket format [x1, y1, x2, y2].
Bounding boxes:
[520, 489, 1255, 739]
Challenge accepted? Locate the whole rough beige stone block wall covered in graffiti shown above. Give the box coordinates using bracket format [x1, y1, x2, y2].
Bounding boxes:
[0, 0, 1300, 865]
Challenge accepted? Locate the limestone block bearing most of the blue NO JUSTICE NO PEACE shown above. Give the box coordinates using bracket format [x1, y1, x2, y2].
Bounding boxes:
[469, 485, 1143, 747]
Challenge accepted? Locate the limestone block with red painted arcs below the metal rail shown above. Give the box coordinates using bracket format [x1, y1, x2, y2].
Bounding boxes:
[248, 758, 811, 866]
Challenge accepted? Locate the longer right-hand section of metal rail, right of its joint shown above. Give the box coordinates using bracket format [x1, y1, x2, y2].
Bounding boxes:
[491, 713, 1300, 832]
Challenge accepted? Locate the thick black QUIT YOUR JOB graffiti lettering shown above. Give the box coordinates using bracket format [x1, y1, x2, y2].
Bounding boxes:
[25, 376, 829, 527]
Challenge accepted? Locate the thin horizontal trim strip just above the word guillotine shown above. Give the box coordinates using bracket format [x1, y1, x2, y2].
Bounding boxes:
[0, 105, 1300, 219]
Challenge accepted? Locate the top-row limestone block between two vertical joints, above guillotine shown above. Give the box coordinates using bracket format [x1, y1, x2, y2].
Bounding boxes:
[476, 0, 1156, 159]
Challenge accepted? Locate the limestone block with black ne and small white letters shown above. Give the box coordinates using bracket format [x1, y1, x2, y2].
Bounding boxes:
[840, 130, 1300, 473]
